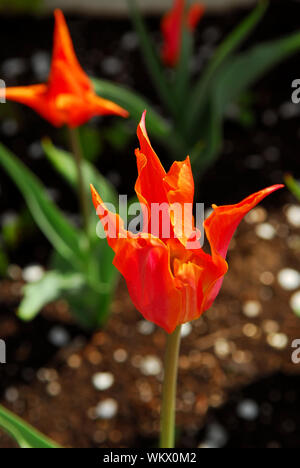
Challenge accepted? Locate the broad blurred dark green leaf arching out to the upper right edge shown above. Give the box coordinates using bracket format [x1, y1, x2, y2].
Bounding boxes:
[191, 33, 300, 176]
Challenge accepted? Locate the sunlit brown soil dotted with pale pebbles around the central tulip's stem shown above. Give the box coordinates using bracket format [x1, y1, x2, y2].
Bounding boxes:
[0, 202, 300, 447]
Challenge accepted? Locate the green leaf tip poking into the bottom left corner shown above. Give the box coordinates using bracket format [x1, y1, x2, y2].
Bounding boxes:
[0, 405, 61, 448]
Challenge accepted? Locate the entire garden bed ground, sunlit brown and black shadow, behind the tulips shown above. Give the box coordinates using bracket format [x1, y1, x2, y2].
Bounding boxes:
[0, 2, 300, 447]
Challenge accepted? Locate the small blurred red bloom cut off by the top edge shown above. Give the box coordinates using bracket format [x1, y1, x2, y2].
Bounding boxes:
[161, 0, 205, 67]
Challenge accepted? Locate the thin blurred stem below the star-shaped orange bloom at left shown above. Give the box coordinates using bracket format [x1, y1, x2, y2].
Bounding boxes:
[68, 127, 89, 236]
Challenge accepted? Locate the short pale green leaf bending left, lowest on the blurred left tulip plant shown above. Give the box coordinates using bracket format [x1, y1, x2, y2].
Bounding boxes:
[18, 271, 84, 321]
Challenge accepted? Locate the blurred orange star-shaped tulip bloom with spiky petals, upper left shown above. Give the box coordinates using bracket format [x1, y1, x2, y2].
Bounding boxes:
[5, 10, 128, 127]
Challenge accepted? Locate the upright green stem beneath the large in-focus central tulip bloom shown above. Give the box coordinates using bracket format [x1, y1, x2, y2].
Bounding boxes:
[160, 325, 181, 448]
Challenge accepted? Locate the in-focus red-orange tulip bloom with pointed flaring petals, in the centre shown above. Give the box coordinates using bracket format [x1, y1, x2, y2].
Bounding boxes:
[92, 114, 282, 333]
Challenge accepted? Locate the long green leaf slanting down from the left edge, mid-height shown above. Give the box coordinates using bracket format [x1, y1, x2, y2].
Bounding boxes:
[0, 144, 84, 266]
